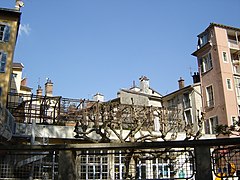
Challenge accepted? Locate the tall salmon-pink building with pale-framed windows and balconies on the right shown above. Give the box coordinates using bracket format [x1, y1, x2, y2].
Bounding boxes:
[192, 23, 240, 134]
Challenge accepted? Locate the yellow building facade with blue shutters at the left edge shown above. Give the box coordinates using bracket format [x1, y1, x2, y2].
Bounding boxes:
[0, 8, 21, 108]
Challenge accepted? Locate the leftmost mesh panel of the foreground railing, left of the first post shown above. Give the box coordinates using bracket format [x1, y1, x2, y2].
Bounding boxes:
[0, 150, 58, 180]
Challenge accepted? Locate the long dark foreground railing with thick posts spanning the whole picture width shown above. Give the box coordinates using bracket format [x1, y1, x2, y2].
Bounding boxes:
[0, 138, 240, 180]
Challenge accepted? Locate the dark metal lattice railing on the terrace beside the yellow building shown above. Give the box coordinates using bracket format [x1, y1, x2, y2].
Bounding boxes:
[7, 93, 61, 124]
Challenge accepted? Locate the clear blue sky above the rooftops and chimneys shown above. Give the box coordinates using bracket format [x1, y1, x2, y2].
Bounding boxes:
[0, 0, 240, 100]
